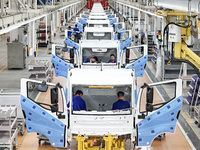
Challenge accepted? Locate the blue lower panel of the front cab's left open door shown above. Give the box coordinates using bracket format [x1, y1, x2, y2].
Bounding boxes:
[21, 95, 66, 147]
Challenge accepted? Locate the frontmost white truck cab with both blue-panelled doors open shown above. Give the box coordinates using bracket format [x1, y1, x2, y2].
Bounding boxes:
[21, 69, 182, 150]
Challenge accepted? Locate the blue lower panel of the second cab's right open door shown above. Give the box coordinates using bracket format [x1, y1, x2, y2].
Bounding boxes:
[126, 55, 148, 77]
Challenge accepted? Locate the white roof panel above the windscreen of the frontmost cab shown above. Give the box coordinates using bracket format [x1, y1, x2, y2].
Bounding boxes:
[70, 69, 134, 86]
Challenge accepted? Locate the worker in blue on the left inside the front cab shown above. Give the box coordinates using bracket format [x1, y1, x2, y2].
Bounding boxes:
[67, 90, 86, 111]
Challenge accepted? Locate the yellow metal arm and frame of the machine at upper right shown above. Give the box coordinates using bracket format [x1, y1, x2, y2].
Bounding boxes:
[157, 10, 200, 74]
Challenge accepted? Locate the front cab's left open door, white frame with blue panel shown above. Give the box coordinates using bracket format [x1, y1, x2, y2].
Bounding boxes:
[20, 79, 68, 148]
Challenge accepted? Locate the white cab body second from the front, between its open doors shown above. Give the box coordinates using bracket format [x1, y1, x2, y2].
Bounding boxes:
[79, 40, 120, 69]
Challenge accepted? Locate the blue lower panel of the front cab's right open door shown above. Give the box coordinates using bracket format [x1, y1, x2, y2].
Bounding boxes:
[137, 96, 182, 146]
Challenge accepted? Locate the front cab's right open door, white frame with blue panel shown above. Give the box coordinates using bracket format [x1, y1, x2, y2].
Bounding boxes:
[136, 79, 182, 147]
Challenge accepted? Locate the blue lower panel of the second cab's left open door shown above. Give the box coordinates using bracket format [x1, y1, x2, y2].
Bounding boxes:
[52, 54, 73, 78]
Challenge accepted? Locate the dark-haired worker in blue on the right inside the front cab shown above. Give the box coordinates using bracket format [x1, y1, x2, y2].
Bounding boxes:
[112, 91, 130, 110]
